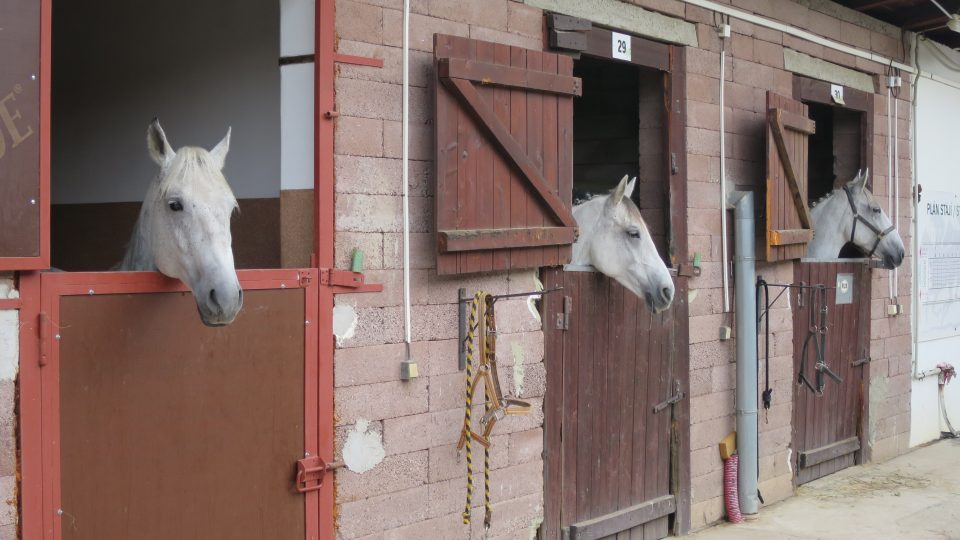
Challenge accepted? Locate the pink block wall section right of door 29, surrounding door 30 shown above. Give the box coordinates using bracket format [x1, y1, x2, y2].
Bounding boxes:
[687, 0, 912, 528]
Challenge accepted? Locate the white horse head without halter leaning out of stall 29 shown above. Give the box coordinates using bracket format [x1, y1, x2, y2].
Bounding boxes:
[573, 176, 674, 313]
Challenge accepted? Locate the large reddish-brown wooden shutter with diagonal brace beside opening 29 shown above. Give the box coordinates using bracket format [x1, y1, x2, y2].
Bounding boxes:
[434, 34, 581, 274]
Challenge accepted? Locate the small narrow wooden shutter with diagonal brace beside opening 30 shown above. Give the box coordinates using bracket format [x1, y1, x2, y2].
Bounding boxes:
[765, 92, 815, 261]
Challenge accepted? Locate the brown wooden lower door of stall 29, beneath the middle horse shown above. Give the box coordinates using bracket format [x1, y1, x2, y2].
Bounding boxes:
[543, 268, 687, 540]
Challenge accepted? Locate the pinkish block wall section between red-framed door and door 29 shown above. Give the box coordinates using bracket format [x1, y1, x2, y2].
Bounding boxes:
[334, 0, 546, 539]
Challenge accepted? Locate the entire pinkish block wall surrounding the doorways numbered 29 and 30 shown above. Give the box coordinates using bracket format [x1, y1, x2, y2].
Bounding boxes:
[335, 0, 912, 538]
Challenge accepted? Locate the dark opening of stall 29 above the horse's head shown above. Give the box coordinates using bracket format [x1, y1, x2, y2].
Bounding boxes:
[573, 57, 670, 265]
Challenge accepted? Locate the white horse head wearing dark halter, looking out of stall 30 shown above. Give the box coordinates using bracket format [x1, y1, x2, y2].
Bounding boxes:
[807, 169, 904, 268]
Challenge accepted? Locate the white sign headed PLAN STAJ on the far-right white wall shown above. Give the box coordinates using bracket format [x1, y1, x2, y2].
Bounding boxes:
[917, 190, 960, 340]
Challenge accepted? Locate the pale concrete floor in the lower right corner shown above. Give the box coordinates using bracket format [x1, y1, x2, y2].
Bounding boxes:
[689, 439, 960, 540]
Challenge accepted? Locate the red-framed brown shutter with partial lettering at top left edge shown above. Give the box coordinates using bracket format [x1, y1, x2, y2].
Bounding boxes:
[0, 0, 50, 270]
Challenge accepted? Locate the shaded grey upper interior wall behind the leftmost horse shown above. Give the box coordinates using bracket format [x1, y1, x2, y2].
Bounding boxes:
[52, 0, 282, 203]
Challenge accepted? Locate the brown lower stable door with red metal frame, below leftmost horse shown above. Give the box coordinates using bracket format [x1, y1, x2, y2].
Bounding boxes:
[40, 270, 324, 540]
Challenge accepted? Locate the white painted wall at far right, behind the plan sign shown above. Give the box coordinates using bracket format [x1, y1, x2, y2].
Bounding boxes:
[910, 42, 960, 446]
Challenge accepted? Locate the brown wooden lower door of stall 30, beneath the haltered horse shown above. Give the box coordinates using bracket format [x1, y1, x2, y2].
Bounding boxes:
[793, 262, 871, 484]
